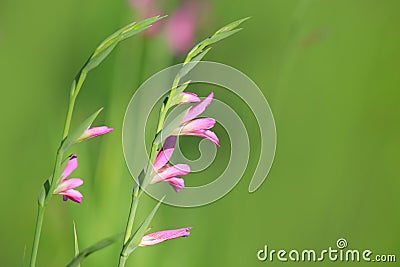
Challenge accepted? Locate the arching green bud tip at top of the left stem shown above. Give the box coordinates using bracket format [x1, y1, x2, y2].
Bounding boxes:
[83, 16, 166, 72]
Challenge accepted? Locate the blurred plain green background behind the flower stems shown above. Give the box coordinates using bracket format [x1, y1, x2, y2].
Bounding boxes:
[0, 0, 400, 267]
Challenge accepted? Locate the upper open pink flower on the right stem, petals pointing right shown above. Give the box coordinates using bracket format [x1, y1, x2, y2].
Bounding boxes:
[172, 93, 219, 146]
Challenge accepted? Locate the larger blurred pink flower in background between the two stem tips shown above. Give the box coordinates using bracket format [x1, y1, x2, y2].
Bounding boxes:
[166, 1, 197, 55]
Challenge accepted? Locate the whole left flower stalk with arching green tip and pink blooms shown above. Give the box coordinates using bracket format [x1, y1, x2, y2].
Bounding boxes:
[30, 16, 161, 267]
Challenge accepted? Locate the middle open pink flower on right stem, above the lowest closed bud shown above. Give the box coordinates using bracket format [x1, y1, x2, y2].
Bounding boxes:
[150, 136, 190, 192]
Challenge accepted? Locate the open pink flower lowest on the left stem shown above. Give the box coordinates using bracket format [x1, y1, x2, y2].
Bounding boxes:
[54, 154, 83, 203]
